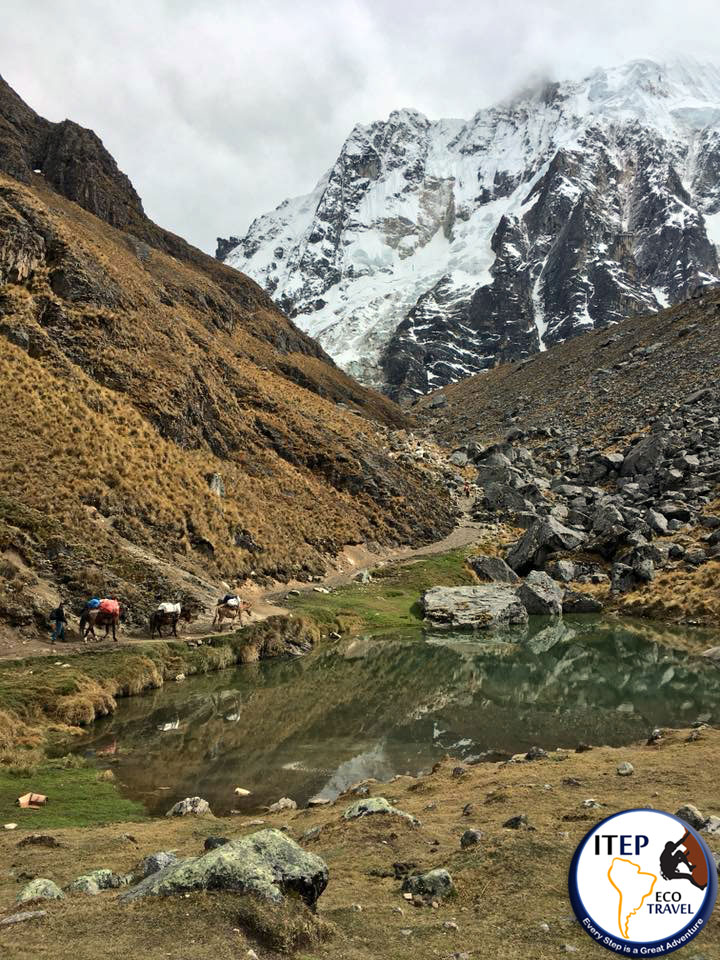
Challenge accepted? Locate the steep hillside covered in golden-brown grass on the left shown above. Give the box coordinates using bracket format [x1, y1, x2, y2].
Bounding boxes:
[0, 77, 454, 643]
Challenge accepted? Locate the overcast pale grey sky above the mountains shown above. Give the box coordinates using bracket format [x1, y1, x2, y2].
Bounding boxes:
[0, 0, 720, 252]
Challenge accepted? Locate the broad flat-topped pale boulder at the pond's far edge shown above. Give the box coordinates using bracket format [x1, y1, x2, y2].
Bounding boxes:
[422, 584, 527, 630]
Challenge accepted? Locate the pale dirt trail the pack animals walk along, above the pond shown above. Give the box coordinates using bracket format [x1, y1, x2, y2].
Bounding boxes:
[0, 497, 487, 661]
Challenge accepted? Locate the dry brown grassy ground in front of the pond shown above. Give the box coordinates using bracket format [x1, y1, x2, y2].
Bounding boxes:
[0, 728, 720, 960]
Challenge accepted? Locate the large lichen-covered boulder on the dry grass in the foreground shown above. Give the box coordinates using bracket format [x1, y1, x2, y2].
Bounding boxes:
[120, 830, 329, 907]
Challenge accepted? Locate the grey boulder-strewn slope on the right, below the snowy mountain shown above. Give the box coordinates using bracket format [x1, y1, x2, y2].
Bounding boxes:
[419, 292, 720, 624]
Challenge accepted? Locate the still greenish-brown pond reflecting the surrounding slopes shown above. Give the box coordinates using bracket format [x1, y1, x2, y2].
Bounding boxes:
[74, 619, 720, 812]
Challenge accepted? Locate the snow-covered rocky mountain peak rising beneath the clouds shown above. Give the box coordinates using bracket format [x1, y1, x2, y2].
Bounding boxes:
[217, 60, 720, 397]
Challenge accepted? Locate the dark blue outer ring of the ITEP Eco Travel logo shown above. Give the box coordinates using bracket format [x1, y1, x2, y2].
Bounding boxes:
[568, 807, 718, 956]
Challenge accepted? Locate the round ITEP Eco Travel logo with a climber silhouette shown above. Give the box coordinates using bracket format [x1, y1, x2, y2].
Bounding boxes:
[569, 810, 718, 957]
